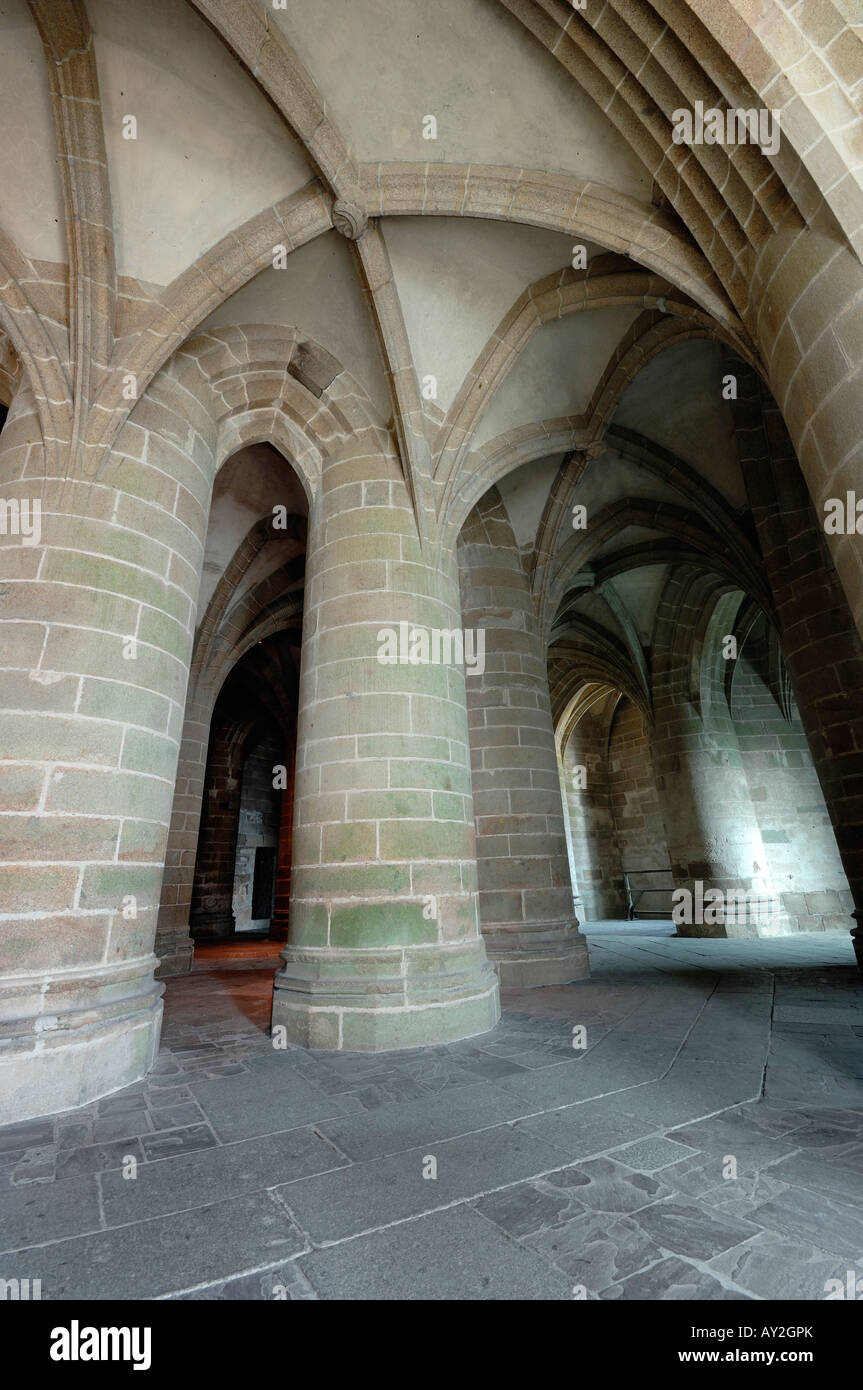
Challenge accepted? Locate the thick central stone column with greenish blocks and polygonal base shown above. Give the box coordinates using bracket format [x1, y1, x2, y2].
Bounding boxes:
[272, 439, 499, 1052]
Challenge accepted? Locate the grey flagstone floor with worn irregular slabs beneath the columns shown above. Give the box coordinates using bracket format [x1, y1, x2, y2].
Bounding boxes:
[0, 923, 863, 1300]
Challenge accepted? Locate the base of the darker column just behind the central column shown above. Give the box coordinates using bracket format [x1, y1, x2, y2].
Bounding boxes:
[482, 920, 591, 990]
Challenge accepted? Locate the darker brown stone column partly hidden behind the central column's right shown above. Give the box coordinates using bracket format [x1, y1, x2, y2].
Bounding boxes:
[460, 489, 589, 988]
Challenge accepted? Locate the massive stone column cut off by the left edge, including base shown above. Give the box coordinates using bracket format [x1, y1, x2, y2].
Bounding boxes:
[0, 396, 210, 1123]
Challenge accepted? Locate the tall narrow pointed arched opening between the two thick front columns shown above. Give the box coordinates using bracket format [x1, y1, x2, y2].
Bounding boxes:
[156, 442, 309, 974]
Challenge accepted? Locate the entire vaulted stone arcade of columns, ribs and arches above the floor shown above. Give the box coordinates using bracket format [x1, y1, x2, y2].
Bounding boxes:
[0, 0, 863, 1295]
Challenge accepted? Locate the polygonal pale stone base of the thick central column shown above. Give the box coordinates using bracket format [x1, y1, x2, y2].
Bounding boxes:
[272, 941, 500, 1052]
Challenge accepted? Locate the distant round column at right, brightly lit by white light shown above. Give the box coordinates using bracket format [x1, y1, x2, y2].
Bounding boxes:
[650, 569, 788, 937]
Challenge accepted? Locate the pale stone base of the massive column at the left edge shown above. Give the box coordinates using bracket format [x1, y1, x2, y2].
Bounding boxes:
[0, 956, 164, 1125]
